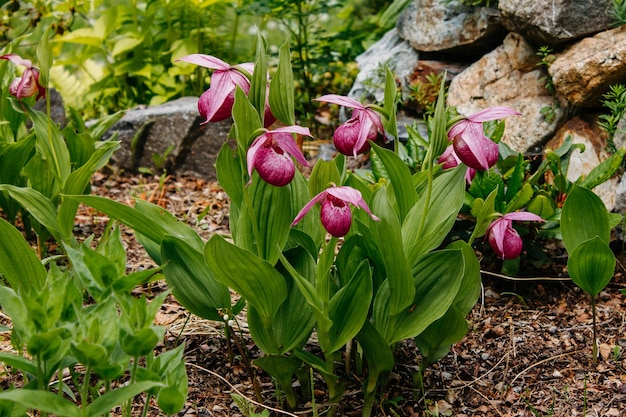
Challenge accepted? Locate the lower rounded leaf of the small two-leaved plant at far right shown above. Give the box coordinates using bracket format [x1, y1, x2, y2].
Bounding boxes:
[567, 236, 616, 297]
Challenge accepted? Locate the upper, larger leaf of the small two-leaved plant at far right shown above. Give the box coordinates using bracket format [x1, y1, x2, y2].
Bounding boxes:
[561, 185, 611, 253]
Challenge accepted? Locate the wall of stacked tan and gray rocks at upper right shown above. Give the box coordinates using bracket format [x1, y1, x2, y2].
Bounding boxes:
[350, 0, 626, 211]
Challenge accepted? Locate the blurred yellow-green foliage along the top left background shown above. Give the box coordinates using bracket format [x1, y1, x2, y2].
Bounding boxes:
[0, 0, 392, 119]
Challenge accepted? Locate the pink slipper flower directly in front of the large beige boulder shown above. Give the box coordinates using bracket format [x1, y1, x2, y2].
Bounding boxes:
[448, 106, 520, 171]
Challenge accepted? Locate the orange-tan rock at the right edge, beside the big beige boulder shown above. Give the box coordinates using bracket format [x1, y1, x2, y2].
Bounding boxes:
[549, 26, 626, 107]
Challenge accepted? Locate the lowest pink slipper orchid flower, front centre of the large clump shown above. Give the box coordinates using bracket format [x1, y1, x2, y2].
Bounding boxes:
[291, 186, 380, 237]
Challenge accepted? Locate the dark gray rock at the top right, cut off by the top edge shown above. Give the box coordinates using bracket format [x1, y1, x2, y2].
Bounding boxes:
[498, 0, 613, 47]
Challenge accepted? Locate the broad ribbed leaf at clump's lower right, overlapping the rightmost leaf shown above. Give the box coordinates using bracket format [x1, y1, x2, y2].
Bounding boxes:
[373, 249, 464, 345]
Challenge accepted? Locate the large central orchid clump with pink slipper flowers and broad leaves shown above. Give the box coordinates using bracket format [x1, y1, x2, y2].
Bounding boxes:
[73, 38, 536, 416]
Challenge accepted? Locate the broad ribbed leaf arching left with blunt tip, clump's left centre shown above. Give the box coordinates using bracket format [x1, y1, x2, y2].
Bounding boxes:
[204, 235, 287, 321]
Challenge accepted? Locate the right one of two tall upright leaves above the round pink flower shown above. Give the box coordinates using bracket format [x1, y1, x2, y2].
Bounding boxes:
[269, 42, 296, 126]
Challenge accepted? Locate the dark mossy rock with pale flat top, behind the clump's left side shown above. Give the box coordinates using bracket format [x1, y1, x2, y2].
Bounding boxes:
[108, 97, 232, 180]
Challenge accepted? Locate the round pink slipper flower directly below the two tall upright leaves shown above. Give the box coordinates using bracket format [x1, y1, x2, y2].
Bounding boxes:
[247, 126, 311, 187]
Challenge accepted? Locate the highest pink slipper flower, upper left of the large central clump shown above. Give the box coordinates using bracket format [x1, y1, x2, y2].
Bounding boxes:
[177, 54, 254, 124]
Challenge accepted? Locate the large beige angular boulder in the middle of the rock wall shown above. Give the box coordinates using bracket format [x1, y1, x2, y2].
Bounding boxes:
[448, 33, 565, 152]
